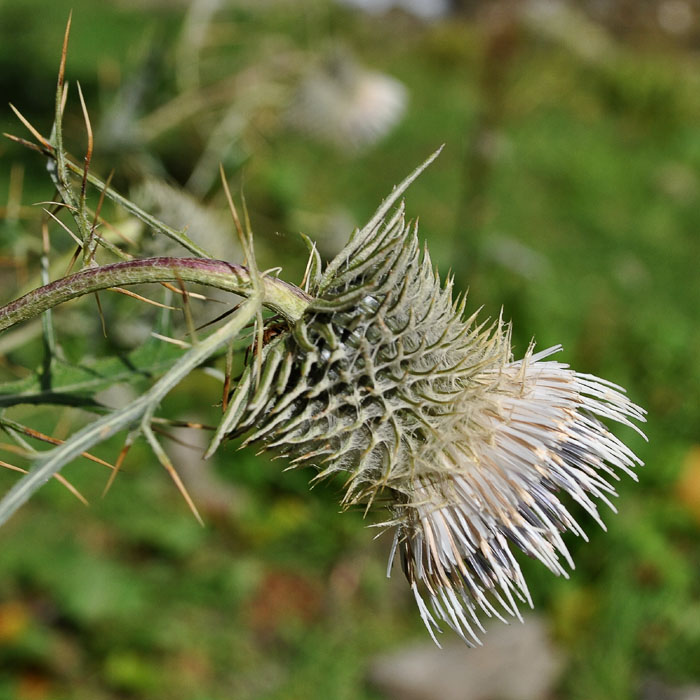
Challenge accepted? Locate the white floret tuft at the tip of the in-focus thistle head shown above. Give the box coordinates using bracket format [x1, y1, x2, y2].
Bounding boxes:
[390, 347, 644, 643]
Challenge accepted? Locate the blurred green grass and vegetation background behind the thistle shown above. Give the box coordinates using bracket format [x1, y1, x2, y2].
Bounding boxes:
[0, 0, 700, 700]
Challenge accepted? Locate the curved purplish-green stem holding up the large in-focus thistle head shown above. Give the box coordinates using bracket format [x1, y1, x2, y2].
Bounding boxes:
[0, 257, 311, 331]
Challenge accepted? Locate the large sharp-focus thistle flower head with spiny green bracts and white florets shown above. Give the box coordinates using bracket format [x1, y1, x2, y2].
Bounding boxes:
[223, 153, 644, 643]
